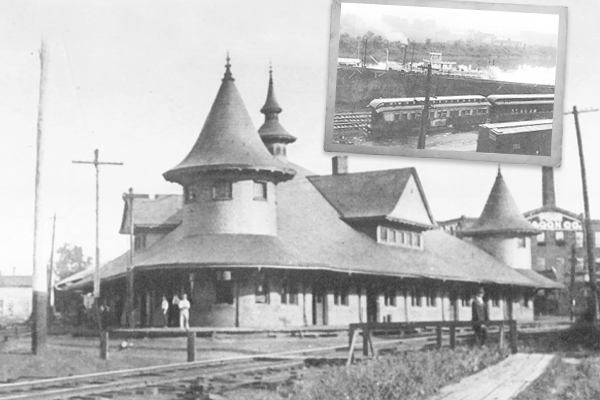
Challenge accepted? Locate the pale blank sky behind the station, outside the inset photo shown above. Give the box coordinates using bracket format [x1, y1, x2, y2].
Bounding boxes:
[0, 0, 600, 274]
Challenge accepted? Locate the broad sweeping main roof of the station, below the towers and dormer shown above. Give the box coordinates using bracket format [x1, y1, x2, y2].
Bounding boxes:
[60, 170, 537, 288]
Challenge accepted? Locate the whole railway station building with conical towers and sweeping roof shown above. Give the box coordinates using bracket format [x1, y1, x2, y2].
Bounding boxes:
[57, 60, 557, 328]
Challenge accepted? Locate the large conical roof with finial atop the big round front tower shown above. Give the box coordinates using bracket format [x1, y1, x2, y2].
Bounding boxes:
[163, 55, 295, 184]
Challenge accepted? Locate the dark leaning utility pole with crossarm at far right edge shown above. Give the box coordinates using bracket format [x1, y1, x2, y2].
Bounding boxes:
[565, 106, 598, 324]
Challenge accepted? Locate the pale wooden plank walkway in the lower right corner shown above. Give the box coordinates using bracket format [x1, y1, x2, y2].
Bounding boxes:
[430, 353, 554, 400]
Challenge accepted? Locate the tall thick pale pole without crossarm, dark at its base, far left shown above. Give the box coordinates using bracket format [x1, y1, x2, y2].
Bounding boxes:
[31, 42, 48, 355]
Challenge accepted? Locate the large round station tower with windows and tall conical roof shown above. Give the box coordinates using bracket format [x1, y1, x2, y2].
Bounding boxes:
[163, 55, 295, 236]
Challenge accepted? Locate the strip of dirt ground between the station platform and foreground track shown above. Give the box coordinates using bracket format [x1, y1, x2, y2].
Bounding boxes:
[0, 334, 348, 383]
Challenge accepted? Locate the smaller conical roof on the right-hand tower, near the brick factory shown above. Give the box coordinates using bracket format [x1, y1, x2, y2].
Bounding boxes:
[461, 168, 540, 237]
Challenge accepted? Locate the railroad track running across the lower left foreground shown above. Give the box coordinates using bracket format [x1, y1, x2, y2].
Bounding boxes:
[0, 346, 346, 400]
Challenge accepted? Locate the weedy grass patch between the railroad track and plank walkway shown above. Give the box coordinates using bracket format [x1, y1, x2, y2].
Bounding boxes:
[245, 347, 506, 400]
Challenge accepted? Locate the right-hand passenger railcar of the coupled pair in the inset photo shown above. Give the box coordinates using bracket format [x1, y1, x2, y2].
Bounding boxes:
[487, 94, 554, 123]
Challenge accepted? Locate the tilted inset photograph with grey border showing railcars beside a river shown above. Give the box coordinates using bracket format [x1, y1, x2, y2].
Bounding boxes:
[325, 1, 566, 166]
